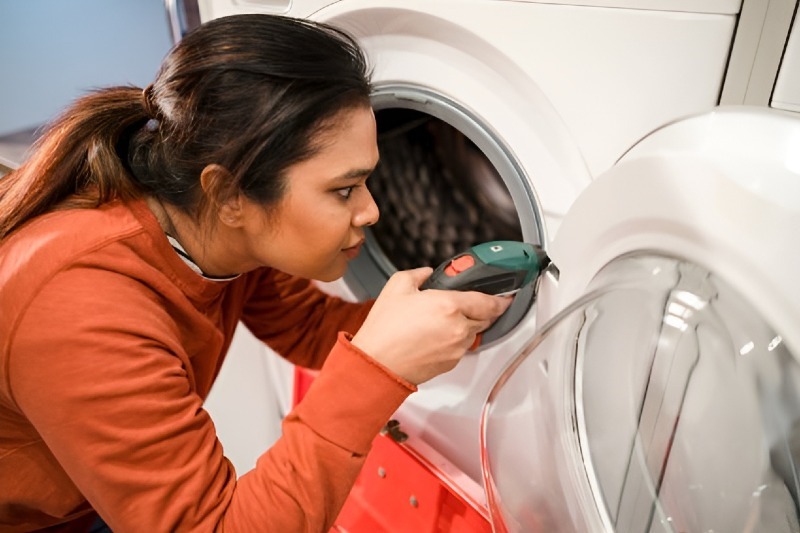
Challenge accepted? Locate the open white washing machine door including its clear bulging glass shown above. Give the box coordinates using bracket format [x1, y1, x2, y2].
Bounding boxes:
[481, 109, 800, 532]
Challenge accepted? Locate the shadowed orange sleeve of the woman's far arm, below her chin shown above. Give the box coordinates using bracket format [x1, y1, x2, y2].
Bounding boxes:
[242, 269, 373, 369]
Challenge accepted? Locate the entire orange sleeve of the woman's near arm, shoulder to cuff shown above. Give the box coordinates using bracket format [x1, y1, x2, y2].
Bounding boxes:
[9, 270, 415, 533]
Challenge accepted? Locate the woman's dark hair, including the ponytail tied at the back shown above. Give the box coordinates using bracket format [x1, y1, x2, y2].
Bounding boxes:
[0, 15, 371, 239]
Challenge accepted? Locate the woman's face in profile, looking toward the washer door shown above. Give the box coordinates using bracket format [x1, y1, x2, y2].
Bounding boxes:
[239, 103, 378, 281]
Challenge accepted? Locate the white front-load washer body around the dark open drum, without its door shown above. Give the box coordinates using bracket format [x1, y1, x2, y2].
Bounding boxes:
[199, 0, 740, 482]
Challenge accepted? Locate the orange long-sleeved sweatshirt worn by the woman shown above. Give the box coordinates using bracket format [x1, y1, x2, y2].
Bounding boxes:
[0, 197, 415, 533]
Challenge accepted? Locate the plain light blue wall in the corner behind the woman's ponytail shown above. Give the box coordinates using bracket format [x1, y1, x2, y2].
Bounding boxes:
[0, 0, 171, 136]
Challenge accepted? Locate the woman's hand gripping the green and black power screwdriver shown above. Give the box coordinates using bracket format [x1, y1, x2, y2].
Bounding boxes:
[352, 267, 511, 385]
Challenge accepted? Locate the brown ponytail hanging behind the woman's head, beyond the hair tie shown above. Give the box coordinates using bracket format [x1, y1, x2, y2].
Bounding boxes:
[0, 87, 148, 241]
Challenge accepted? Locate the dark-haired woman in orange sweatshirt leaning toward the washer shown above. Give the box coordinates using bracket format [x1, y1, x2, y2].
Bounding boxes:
[0, 15, 508, 532]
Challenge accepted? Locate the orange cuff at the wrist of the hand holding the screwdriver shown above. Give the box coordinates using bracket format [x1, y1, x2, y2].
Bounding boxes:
[289, 332, 417, 455]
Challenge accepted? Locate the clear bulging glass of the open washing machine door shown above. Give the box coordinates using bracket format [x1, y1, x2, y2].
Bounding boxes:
[481, 255, 800, 532]
